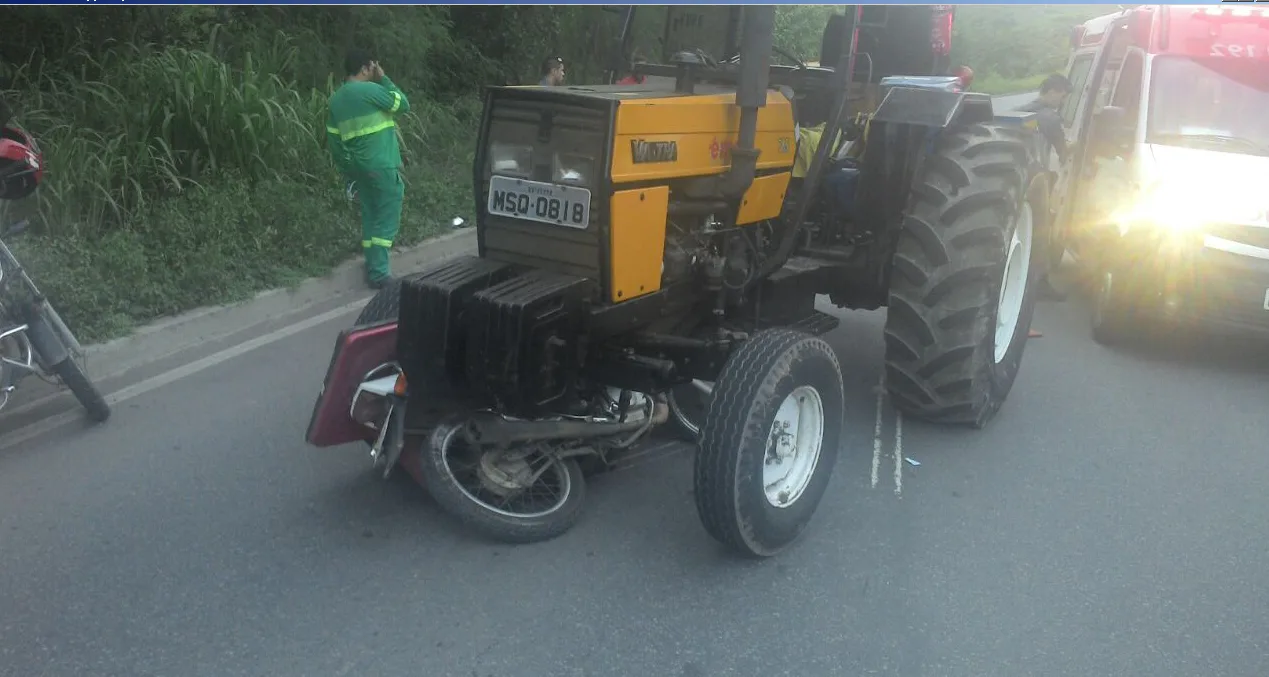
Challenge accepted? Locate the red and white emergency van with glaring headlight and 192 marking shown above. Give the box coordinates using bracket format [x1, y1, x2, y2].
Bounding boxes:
[1053, 5, 1269, 343]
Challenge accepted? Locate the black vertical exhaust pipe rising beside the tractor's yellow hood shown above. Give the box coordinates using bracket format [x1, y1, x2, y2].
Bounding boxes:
[718, 5, 775, 199]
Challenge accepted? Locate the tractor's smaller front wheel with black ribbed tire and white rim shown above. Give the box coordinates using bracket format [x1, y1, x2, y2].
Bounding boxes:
[693, 329, 845, 558]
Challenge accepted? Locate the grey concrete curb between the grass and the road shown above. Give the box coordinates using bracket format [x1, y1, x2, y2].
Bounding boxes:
[84, 229, 476, 381]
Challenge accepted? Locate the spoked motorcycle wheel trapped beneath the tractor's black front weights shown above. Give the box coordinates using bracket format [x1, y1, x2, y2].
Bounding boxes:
[420, 419, 586, 544]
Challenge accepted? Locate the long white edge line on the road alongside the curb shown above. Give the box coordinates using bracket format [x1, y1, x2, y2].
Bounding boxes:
[0, 298, 365, 450]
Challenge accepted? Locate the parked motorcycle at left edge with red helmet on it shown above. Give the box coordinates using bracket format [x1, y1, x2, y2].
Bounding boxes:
[0, 117, 110, 423]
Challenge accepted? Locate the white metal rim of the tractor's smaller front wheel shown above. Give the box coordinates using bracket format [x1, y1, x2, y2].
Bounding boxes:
[763, 386, 824, 508]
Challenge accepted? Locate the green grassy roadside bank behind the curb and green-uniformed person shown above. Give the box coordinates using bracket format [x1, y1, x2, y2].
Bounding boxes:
[3, 32, 480, 340]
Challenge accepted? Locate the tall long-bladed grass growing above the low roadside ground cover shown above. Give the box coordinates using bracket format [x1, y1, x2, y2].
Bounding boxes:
[18, 34, 325, 235]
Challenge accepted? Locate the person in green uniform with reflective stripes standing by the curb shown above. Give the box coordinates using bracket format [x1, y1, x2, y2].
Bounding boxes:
[326, 50, 410, 288]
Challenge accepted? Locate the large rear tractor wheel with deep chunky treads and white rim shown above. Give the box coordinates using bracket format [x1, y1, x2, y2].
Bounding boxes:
[886, 124, 1048, 428]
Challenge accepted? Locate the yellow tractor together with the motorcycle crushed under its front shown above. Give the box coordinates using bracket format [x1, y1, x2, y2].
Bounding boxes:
[308, 5, 1051, 556]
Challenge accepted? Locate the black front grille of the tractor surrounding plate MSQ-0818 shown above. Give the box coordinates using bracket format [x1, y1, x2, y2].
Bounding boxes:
[477, 93, 609, 281]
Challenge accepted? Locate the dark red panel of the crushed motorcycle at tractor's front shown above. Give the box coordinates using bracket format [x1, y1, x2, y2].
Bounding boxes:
[305, 321, 397, 447]
